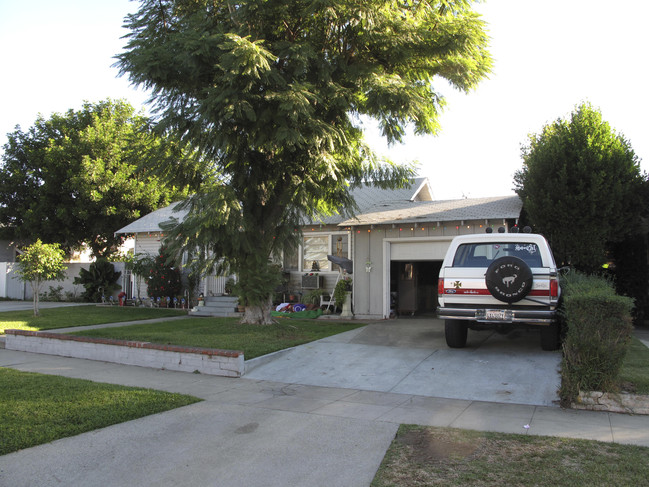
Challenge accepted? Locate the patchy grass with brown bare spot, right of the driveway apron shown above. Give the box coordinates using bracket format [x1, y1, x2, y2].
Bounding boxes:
[372, 425, 649, 487]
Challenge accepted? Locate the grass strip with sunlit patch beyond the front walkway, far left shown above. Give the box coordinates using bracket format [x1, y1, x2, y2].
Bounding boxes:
[0, 306, 187, 333]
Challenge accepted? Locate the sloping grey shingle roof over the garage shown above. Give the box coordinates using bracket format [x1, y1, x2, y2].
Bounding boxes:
[340, 195, 523, 226]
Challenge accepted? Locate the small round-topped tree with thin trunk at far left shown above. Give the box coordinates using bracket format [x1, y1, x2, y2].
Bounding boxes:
[17, 239, 67, 316]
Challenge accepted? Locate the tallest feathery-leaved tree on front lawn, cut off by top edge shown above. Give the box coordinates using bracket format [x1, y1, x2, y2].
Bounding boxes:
[118, 0, 491, 323]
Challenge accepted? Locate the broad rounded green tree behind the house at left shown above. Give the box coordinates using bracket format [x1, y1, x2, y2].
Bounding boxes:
[0, 100, 201, 256]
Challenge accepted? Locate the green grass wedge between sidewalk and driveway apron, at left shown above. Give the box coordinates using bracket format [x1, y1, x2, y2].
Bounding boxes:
[0, 368, 200, 455]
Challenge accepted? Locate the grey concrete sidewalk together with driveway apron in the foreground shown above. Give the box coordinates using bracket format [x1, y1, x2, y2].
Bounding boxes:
[0, 350, 649, 486]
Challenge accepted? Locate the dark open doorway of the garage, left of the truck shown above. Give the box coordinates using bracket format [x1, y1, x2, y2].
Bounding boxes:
[390, 260, 442, 316]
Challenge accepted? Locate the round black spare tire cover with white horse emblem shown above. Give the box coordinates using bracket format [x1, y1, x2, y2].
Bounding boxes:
[485, 256, 533, 303]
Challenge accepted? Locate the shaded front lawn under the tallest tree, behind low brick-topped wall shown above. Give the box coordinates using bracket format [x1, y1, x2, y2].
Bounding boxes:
[71, 318, 365, 360]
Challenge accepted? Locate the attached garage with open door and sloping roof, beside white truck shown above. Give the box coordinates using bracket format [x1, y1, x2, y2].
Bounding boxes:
[338, 196, 521, 319]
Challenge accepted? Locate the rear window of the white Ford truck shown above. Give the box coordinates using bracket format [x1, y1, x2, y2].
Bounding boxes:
[453, 242, 543, 268]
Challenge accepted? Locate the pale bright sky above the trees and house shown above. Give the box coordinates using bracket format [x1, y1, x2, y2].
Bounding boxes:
[0, 0, 649, 200]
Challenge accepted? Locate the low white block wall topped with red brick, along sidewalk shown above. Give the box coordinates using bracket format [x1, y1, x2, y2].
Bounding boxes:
[5, 330, 245, 377]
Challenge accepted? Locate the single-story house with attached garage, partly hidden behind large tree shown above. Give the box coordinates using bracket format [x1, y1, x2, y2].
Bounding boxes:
[116, 178, 522, 319]
